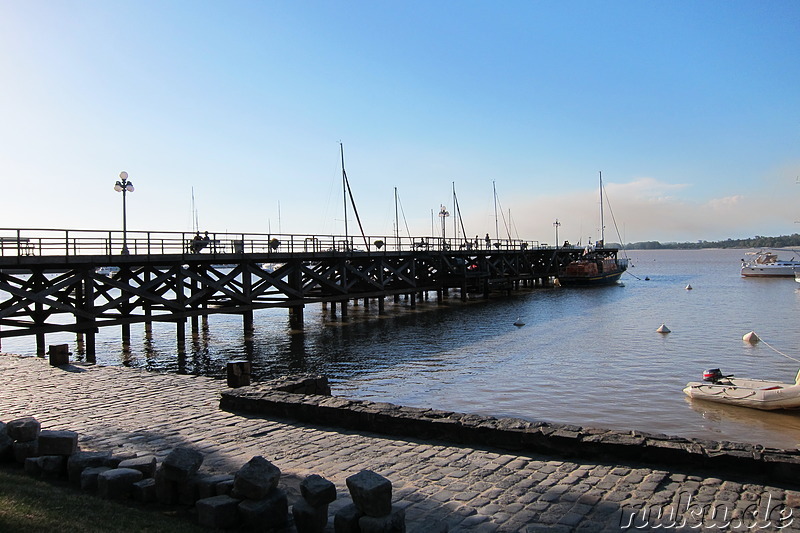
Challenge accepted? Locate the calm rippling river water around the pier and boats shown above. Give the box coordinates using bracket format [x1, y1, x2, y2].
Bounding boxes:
[2, 250, 800, 447]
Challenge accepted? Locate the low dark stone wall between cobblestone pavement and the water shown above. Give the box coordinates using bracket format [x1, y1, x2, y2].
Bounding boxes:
[220, 384, 800, 482]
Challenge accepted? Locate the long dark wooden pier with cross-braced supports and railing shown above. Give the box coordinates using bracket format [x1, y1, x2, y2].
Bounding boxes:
[0, 228, 617, 361]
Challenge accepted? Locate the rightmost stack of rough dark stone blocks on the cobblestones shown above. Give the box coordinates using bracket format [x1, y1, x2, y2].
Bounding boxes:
[333, 470, 406, 533]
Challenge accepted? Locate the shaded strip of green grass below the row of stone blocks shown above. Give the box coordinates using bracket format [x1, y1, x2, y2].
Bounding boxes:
[0, 466, 209, 533]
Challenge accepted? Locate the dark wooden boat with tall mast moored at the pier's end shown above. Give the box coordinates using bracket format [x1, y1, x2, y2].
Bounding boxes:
[558, 173, 628, 286]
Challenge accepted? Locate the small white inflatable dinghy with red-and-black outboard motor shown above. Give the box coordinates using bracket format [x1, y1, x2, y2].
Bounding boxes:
[683, 368, 800, 411]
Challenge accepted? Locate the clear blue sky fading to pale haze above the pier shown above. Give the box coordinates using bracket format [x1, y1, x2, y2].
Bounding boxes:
[0, 0, 800, 243]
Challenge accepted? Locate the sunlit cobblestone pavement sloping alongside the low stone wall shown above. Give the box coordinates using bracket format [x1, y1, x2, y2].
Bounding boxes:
[0, 355, 800, 532]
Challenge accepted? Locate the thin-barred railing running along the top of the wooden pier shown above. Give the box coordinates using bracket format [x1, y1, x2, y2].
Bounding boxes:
[0, 228, 550, 257]
